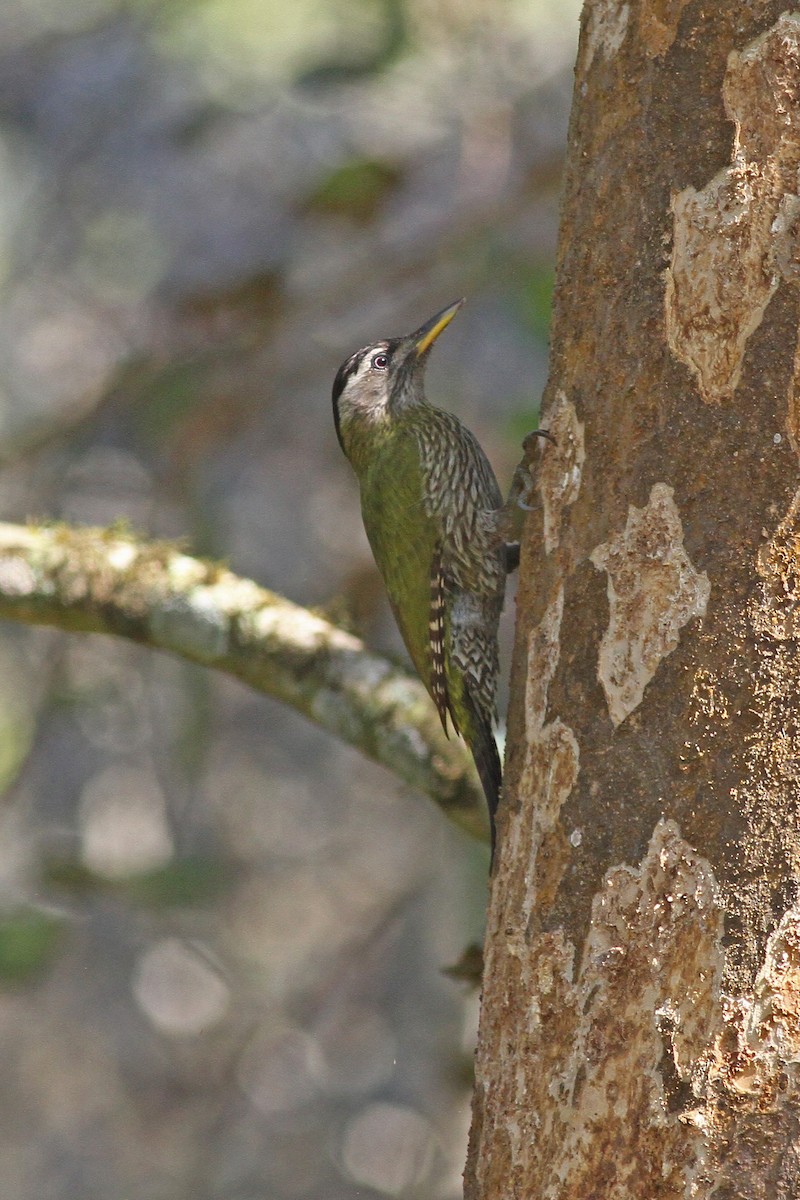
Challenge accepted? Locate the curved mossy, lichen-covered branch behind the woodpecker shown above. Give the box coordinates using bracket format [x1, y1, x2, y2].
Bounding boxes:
[0, 523, 487, 838]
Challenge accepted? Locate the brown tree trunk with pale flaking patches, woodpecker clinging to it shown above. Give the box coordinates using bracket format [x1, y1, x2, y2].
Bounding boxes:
[465, 0, 800, 1200]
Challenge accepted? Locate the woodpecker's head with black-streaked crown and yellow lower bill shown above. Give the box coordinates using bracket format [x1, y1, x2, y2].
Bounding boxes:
[333, 300, 464, 458]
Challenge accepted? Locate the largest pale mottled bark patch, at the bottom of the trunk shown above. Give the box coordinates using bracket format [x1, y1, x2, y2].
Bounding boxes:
[467, 821, 723, 1200]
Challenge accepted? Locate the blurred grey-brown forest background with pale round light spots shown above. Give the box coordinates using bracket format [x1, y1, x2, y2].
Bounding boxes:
[0, 0, 579, 1200]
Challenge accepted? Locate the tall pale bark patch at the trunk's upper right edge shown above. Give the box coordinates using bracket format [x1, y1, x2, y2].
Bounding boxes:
[664, 13, 800, 403]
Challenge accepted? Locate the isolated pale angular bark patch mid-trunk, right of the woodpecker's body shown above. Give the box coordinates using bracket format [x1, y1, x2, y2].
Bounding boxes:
[590, 484, 710, 725]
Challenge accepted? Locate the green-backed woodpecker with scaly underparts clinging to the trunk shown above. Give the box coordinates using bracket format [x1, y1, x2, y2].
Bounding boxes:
[333, 300, 506, 860]
